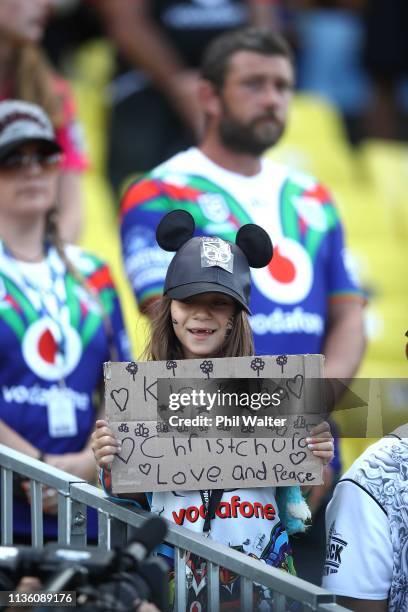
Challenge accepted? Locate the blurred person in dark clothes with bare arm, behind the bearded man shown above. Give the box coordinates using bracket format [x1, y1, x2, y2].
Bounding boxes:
[94, 0, 275, 194]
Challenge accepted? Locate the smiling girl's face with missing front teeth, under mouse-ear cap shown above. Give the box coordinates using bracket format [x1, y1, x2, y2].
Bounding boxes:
[170, 293, 236, 359]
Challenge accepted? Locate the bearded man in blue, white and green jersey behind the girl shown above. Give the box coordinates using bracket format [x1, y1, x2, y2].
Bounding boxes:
[122, 27, 364, 582]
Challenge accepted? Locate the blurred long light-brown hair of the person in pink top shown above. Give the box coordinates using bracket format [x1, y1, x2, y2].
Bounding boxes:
[11, 44, 63, 129]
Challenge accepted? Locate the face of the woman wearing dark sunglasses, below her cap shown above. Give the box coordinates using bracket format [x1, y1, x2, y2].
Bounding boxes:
[0, 143, 60, 217]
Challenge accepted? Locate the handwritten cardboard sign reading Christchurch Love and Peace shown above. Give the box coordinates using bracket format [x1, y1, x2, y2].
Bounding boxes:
[104, 355, 323, 493]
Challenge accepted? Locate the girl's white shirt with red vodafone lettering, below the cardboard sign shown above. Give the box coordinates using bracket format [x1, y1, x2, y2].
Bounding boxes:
[151, 487, 295, 610]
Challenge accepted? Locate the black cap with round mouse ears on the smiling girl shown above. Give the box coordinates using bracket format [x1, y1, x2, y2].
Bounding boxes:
[156, 210, 273, 314]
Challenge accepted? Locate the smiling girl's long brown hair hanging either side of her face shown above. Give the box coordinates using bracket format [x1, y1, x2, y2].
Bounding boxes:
[143, 296, 254, 361]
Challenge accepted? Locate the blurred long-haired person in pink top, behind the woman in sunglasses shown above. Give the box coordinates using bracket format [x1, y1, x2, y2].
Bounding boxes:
[0, 0, 87, 242]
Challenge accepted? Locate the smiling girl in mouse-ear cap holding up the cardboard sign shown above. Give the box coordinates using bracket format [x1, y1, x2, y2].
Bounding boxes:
[93, 211, 333, 609]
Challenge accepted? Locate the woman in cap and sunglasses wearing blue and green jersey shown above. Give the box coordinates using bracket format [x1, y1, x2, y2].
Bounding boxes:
[0, 100, 129, 541]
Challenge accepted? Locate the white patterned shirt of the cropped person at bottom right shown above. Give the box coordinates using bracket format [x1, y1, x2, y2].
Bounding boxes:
[323, 436, 408, 612]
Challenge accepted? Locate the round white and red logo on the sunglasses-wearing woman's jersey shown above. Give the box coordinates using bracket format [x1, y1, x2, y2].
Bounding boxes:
[21, 317, 82, 381]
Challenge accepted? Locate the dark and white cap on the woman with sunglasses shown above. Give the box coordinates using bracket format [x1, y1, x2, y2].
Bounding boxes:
[0, 100, 61, 159]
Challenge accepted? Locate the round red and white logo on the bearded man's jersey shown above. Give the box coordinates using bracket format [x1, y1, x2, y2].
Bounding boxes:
[252, 236, 313, 304]
